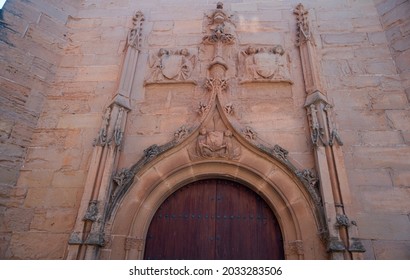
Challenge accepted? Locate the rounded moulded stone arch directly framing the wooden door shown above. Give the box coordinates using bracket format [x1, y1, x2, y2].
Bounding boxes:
[105, 149, 326, 259]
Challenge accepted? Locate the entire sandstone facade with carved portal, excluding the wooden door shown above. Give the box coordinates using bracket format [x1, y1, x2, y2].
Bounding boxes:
[0, 0, 410, 259]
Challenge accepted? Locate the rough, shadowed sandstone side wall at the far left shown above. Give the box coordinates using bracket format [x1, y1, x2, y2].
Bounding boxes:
[0, 0, 80, 258]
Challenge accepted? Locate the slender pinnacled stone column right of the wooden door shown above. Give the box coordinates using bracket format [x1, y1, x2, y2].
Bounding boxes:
[294, 4, 364, 259]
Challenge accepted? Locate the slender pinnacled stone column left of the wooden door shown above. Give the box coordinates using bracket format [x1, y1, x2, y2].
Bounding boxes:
[67, 12, 144, 259]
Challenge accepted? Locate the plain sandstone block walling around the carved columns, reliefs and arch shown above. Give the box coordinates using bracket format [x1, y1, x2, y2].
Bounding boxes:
[0, 0, 410, 259]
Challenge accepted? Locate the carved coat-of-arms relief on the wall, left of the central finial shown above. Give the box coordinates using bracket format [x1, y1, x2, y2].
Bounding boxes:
[145, 48, 197, 84]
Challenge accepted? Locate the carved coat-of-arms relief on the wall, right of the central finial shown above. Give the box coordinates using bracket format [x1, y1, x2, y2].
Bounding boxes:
[238, 45, 293, 84]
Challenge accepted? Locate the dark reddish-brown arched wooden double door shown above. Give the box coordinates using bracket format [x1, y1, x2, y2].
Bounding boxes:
[144, 179, 284, 260]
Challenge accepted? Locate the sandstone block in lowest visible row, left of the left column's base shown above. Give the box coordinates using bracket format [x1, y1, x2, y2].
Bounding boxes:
[7, 231, 69, 260]
